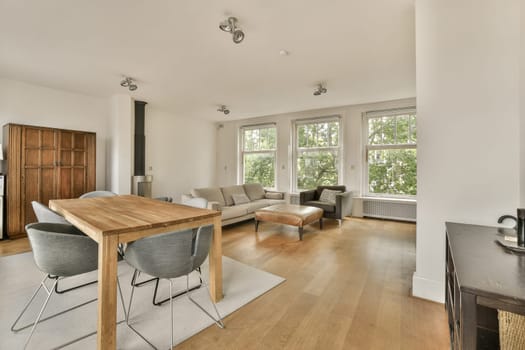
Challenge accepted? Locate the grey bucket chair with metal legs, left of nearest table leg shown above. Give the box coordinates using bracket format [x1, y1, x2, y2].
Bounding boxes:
[11, 223, 126, 349]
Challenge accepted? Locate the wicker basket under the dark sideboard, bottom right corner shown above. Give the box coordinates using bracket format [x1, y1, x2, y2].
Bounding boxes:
[498, 310, 525, 350]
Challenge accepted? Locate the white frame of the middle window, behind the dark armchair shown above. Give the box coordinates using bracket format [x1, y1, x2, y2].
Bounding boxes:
[291, 115, 344, 193]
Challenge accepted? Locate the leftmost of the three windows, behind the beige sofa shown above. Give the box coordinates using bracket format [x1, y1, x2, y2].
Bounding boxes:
[241, 124, 277, 188]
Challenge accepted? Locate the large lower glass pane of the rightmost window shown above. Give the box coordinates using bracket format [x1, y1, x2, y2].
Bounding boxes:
[368, 149, 417, 196]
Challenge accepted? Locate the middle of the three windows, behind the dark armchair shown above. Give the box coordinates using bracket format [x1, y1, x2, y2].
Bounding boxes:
[294, 117, 341, 191]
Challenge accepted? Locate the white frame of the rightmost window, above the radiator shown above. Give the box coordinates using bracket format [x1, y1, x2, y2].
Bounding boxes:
[362, 106, 417, 200]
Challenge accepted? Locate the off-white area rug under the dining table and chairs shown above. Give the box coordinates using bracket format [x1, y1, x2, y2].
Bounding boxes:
[0, 253, 284, 349]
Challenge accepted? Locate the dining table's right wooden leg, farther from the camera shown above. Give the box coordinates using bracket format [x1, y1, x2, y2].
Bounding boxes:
[209, 216, 222, 302]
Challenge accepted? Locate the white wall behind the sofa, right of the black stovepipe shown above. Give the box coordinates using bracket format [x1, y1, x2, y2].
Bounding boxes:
[145, 105, 216, 202]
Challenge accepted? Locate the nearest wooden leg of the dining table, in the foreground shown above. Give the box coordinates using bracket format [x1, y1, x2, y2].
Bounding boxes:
[97, 236, 118, 350]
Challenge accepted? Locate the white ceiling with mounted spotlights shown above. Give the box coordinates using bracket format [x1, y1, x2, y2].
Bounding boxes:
[0, 0, 415, 121]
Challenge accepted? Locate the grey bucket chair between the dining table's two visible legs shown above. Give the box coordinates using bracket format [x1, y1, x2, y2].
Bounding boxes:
[124, 225, 224, 349]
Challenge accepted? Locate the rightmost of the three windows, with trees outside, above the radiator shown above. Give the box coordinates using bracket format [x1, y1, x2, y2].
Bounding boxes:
[364, 109, 417, 197]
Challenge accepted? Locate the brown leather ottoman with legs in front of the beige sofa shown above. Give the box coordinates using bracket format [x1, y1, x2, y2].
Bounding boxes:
[255, 204, 323, 241]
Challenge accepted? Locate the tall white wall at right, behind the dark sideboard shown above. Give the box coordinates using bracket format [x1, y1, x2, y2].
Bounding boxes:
[413, 0, 520, 301]
